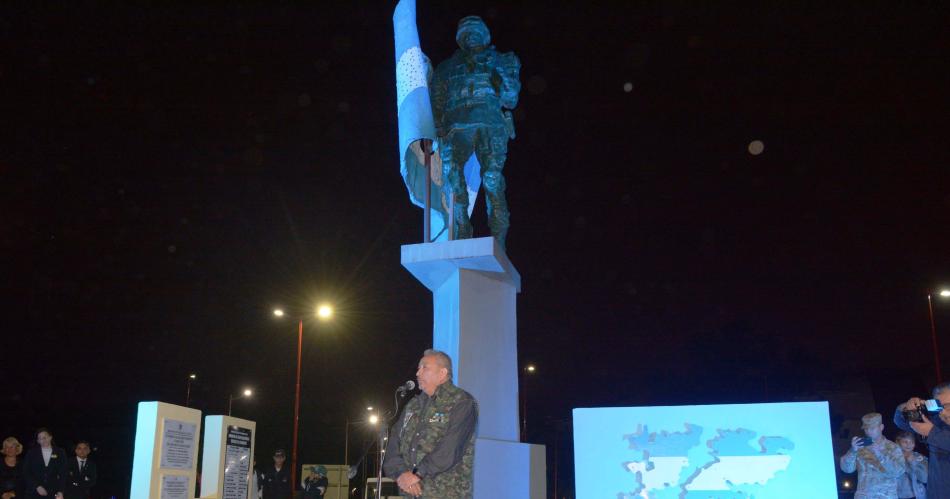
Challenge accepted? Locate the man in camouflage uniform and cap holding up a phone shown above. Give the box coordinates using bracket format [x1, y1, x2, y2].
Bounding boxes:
[841, 412, 905, 499]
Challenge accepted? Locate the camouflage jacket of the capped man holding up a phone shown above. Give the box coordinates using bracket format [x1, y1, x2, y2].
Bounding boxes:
[841, 438, 906, 499]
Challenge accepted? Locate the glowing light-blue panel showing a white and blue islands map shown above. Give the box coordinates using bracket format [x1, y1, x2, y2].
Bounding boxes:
[574, 402, 837, 499]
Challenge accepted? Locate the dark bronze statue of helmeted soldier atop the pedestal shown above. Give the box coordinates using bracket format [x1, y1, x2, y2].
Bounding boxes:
[431, 16, 521, 247]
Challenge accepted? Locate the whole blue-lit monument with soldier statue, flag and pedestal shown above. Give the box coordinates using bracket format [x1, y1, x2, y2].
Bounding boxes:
[393, 0, 546, 499]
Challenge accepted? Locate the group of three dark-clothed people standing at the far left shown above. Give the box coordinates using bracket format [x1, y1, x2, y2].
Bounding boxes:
[0, 428, 96, 499]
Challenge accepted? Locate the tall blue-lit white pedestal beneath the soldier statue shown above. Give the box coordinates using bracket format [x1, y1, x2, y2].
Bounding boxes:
[402, 237, 547, 499]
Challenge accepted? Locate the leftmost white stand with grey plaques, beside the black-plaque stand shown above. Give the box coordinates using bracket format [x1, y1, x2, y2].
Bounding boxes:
[129, 402, 201, 499]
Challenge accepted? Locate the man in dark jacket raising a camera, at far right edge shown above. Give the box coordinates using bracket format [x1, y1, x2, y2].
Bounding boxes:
[894, 383, 950, 497]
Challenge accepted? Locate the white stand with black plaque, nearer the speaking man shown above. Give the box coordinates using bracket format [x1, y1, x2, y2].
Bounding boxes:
[201, 416, 257, 499]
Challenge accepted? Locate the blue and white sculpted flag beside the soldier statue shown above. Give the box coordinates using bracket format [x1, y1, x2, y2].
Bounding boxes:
[393, 0, 481, 241]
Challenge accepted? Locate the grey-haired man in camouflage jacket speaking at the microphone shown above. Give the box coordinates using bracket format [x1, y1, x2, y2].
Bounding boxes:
[383, 350, 478, 499]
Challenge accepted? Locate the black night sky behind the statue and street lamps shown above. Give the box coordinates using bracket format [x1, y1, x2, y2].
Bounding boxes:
[0, 0, 950, 497]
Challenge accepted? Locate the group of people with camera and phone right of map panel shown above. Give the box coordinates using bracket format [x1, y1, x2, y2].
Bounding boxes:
[840, 383, 950, 499]
